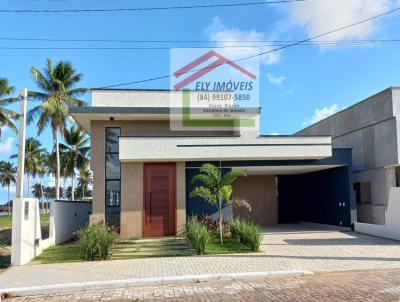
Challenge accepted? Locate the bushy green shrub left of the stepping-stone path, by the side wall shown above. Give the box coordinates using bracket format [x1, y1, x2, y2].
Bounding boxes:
[77, 224, 116, 260]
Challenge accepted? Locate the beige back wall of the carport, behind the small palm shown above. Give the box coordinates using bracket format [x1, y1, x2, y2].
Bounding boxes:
[233, 175, 278, 225]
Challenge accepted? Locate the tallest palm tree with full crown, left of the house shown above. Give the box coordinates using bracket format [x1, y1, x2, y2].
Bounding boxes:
[28, 59, 88, 199]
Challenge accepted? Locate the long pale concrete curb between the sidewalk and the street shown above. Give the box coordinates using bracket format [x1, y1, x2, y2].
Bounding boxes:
[0, 270, 314, 301]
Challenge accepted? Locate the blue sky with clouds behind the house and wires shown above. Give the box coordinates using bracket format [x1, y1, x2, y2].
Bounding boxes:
[0, 0, 400, 203]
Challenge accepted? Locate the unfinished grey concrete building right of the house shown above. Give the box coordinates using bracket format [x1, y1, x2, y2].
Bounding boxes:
[296, 87, 400, 224]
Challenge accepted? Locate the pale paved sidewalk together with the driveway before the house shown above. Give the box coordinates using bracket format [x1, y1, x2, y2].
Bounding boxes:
[0, 225, 400, 288]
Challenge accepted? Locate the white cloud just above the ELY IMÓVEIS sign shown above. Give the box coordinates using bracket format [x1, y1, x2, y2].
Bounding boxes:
[205, 16, 280, 65]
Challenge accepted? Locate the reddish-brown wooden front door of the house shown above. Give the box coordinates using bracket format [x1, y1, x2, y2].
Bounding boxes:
[143, 164, 176, 237]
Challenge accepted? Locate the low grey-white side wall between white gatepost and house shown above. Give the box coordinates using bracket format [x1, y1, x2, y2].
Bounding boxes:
[51, 201, 92, 244]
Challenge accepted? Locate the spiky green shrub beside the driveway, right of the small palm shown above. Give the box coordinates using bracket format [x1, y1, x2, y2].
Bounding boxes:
[230, 218, 261, 252]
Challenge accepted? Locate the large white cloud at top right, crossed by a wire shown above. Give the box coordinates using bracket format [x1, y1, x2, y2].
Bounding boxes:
[290, 0, 390, 46]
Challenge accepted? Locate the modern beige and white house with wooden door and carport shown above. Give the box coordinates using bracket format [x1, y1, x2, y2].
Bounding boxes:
[70, 90, 356, 238]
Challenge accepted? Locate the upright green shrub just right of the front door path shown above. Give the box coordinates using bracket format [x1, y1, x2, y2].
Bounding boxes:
[185, 217, 211, 255]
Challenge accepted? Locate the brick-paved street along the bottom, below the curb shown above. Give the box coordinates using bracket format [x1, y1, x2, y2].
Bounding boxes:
[5, 269, 400, 302]
